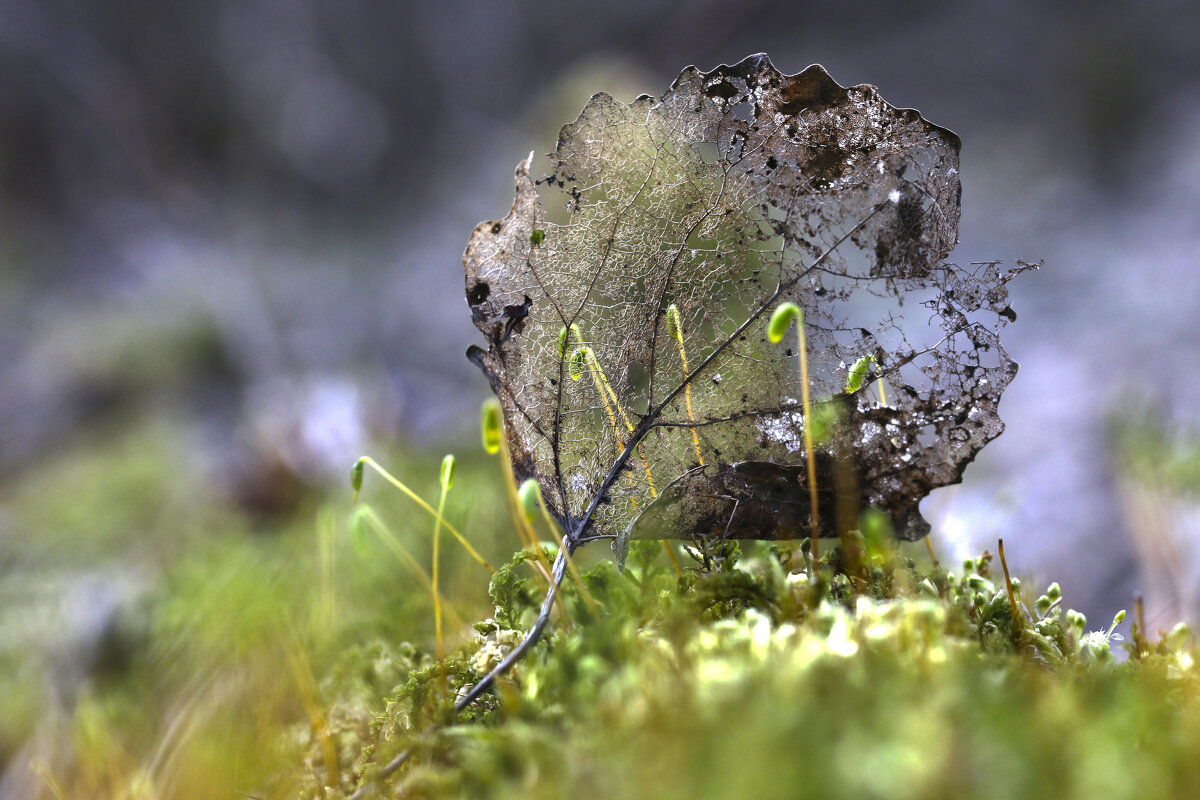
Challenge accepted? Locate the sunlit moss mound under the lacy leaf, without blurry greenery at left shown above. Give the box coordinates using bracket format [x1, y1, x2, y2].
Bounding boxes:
[292, 545, 1200, 800]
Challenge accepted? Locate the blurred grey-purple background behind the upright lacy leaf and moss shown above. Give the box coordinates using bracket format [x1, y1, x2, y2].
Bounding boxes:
[0, 0, 1200, 794]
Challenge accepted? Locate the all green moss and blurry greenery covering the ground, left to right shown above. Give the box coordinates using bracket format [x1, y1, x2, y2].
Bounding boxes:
[7, 410, 1200, 799]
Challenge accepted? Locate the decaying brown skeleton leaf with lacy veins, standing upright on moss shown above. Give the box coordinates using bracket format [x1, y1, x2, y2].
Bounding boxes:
[464, 55, 1020, 566]
